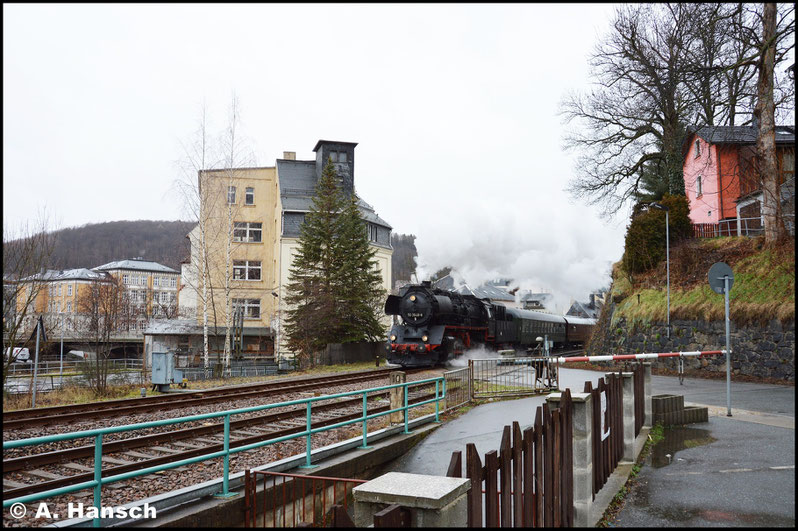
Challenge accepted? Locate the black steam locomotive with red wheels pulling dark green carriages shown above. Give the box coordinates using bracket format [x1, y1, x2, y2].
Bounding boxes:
[385, 282, 595, 367]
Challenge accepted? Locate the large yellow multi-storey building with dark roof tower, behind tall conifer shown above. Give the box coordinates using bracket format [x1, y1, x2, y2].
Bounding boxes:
[181, 140, 393, 359]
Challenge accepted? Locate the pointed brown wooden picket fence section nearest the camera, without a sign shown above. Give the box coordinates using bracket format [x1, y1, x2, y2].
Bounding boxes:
[446, 390, 573, 527]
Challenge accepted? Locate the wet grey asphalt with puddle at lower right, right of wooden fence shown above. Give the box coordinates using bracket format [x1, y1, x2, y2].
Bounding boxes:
[610, 376, 795, 527]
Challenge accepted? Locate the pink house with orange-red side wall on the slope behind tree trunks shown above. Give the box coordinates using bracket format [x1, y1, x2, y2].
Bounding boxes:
[683, 126, 795, 235]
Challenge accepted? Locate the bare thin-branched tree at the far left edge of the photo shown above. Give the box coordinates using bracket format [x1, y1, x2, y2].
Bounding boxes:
[3, 210, 55, 385]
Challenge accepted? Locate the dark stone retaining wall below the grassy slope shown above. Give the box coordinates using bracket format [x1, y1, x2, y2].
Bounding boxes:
[589, 305, 795, 382]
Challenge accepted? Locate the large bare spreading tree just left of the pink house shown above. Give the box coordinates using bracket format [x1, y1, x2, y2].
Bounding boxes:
[561, 4, 696, 214]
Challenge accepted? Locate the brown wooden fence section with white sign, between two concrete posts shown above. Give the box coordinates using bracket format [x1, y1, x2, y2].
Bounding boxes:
[584, 373, 623, 499]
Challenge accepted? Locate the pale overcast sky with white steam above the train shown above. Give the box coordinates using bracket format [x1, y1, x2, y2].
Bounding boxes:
[3, 4, 626, 310]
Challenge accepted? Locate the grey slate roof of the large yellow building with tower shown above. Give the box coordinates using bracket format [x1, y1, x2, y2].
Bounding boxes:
[277, 156, 392, 229]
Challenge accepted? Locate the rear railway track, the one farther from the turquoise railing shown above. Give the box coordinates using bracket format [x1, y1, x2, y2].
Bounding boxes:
[3, 368, 424, 432]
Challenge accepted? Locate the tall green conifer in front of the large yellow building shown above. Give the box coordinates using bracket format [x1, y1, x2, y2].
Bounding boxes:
[285, 161, 384, 364]
